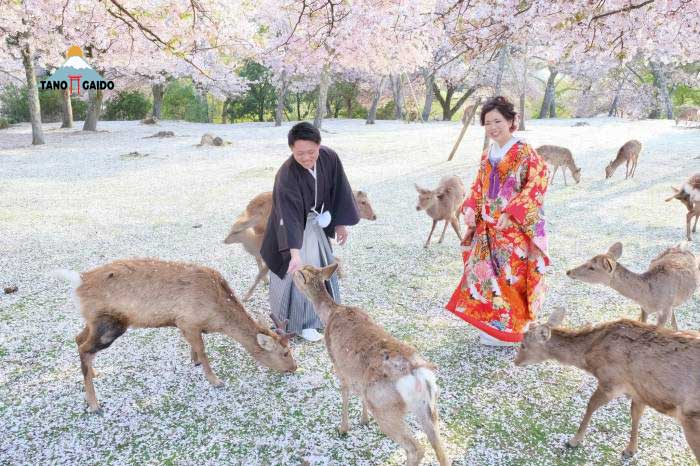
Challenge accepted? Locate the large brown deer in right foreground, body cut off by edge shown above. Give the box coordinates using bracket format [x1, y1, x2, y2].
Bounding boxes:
[515, 309, 700, 461]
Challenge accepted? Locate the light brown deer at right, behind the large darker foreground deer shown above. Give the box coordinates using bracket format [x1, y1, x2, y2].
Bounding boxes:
[566, 242, 700, 330]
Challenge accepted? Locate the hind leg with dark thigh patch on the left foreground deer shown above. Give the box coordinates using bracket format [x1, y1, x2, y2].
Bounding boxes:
[76, 316, 126, 413]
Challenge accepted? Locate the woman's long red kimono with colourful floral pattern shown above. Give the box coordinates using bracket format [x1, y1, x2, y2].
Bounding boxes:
[446, 141, 549, 342]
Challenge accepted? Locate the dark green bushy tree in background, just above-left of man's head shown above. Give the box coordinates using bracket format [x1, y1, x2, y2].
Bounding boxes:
[226, 61, 277, 122]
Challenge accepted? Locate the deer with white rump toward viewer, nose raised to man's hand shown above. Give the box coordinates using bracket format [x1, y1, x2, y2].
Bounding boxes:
[293, 264, 450, 466]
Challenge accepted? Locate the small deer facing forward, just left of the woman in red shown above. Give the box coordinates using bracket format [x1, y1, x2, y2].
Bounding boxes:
[415, 176, 467, 248]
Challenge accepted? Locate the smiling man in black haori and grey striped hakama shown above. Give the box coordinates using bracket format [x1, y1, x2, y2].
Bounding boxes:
[260, 122, 360, 341]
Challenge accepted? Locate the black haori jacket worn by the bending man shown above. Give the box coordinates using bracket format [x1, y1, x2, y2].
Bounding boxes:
[260, 146, 360, 279]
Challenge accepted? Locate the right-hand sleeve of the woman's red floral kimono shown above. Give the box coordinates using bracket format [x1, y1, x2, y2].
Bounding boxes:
[503, 145, 549, 227]
